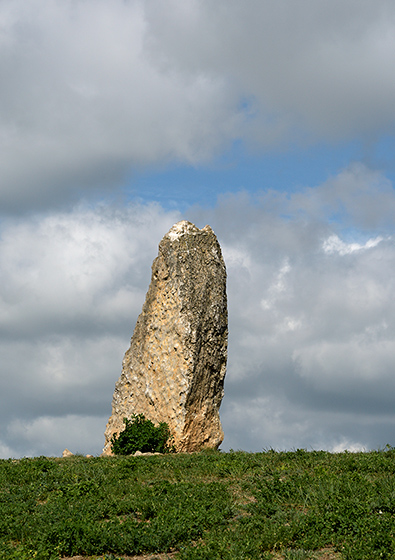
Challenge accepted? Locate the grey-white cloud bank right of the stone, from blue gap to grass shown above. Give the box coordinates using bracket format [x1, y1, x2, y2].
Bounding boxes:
[191, 166, 395, 449]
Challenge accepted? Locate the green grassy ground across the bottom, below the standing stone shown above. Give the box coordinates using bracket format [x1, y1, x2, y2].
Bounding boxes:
[0, 448, 395, 560]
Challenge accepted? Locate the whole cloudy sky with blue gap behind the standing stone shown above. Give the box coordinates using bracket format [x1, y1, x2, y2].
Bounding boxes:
[0, 0, 395, 458]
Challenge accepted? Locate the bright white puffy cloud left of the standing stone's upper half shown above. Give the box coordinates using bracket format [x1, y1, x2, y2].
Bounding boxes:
[0, 204, 178, 338]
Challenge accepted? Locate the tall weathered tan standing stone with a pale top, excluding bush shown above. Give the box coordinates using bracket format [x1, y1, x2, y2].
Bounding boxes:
[103, 221, 228, 455]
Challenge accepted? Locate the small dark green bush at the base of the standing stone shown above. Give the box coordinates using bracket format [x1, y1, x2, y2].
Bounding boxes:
[111, 414, 174, 455]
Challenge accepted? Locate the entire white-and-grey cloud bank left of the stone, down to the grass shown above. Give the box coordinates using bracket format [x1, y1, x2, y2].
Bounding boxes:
[0, 204, 179, 454]
